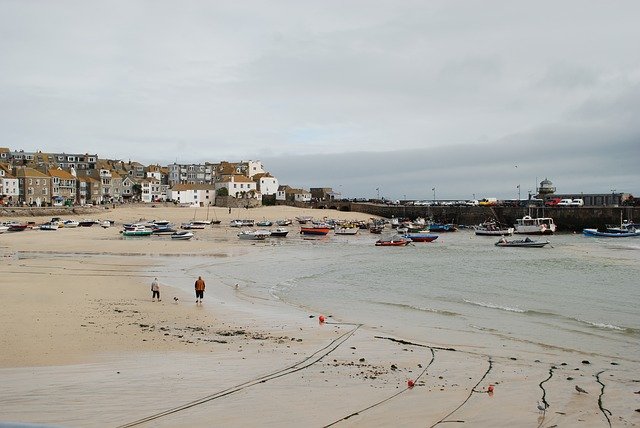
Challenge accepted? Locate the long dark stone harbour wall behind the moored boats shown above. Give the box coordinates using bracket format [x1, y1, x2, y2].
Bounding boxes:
[314, 201, 640, 232]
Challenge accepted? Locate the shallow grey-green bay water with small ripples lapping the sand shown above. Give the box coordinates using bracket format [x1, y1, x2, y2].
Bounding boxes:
[192, 228, 640, 360]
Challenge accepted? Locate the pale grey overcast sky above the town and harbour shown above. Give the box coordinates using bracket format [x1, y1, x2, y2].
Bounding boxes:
[0, 0, 640, 199]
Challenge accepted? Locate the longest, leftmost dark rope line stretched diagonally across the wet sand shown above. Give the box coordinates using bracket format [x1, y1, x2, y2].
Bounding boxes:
[118, 323, 362, 428]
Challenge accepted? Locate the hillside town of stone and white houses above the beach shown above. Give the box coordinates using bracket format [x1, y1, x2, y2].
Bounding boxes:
[0, 147, 331, 207]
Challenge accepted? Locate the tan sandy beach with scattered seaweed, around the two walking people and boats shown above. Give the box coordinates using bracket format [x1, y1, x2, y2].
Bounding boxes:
[0, 206, 640, 427]
